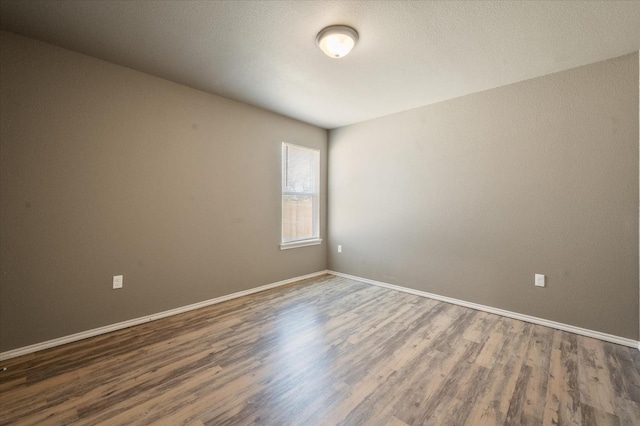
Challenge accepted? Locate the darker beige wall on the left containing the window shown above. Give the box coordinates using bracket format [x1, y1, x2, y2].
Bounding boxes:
[0, 33, 327, 351]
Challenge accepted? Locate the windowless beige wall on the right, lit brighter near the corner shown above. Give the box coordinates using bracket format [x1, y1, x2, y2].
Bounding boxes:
[329, 53, 640, 339]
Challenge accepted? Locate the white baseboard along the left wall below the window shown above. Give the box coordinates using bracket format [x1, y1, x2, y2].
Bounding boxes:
[0, 270, 329, 361]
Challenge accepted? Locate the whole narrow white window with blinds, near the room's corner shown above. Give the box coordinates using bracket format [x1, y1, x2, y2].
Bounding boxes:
[280, 143, 322, 250]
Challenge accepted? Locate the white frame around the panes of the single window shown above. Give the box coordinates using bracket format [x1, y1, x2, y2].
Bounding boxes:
[280, 142, 322, 250]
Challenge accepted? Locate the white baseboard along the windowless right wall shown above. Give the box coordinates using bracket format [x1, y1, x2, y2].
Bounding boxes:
[328, 271, 640, 350]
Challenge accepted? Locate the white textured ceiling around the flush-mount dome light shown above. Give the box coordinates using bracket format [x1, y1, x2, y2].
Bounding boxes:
[0, 0, 640, 128]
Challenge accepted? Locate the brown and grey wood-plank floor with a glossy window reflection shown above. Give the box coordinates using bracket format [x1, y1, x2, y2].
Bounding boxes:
[0, 276, 640, 426]
